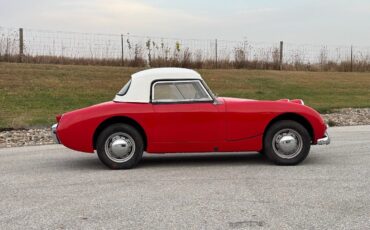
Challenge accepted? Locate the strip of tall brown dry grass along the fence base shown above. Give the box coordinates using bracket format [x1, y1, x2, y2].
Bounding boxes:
[0, 53, 370, 72]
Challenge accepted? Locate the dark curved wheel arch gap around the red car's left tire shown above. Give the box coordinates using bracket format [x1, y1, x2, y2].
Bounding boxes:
[93, 116, 148, 151]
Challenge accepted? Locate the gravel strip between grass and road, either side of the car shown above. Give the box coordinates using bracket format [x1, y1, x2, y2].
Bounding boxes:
[0, 108, 370, 148]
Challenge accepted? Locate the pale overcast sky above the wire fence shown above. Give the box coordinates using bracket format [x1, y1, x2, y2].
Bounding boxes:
[0, 0, 370, 46]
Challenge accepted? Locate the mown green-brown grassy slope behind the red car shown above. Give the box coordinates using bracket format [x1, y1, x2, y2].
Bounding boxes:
[0, 62, 370, 128]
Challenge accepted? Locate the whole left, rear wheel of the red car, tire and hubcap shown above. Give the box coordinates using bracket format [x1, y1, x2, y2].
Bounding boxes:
[96, 124, 144, 169]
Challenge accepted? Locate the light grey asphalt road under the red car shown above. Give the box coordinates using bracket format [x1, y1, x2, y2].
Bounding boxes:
[0, 126, 370, 229]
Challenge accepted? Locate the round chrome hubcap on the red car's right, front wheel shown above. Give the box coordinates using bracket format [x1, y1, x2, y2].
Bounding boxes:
[272, 129, 302, 159]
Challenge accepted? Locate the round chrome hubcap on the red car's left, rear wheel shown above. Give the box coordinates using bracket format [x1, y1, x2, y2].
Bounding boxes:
[105, 132, 135, 163]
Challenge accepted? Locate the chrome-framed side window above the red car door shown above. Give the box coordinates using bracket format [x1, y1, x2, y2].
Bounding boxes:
[152, 80, 212, 102]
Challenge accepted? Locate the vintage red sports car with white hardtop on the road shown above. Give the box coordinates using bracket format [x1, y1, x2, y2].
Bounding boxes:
[52, 68, 330, 169]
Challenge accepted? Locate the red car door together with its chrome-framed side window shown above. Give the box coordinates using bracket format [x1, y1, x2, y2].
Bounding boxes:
[152, 80, 222, 152]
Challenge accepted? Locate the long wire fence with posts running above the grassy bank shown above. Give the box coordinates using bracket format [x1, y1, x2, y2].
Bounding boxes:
[0, 27, 370, 71]
